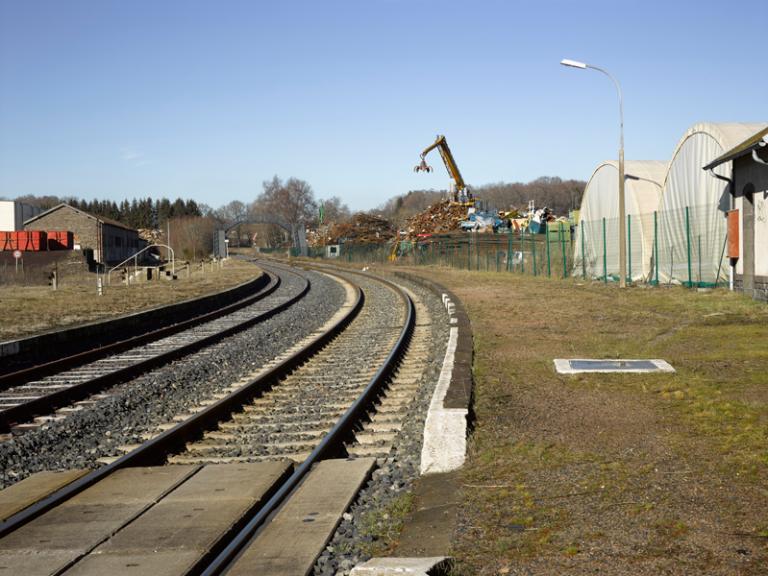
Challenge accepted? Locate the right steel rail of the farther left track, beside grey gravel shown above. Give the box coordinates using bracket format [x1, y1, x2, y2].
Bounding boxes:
[0, 276, 310, 431]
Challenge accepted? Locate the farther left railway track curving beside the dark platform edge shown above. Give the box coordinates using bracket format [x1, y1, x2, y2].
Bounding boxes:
[0, 269, 310, 438]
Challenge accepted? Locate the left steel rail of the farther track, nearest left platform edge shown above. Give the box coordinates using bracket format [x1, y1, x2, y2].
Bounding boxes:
[0, 272, 280, 391]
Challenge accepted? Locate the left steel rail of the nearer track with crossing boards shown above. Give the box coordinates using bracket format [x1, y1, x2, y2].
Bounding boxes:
[0, 270, 364, 538]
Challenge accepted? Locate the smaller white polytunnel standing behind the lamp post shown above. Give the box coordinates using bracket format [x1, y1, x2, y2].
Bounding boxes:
[573, 160, 667, 282]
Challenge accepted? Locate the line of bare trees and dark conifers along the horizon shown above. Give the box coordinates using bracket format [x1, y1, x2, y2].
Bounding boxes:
[6, 176, 586, 258]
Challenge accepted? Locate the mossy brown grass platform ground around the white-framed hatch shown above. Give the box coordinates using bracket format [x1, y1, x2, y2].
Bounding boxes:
[402, 268, 768, 575]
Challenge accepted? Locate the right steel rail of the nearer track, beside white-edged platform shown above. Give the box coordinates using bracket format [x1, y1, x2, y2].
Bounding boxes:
[198, 271, 416, 576]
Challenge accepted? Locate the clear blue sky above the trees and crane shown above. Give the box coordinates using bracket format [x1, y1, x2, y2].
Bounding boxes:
[0, 0, 768, 209]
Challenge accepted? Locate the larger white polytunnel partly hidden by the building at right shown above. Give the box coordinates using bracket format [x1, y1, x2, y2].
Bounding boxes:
[654, 123, 766, 286]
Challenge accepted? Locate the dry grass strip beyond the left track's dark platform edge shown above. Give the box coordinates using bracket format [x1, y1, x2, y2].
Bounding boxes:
[0, 260, 260, 341]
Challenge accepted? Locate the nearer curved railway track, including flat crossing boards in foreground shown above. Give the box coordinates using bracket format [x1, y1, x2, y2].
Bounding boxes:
[0, 268, 448, 575]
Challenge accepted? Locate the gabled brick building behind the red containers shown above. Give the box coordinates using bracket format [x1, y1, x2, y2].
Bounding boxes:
[24, 204, 146, 264]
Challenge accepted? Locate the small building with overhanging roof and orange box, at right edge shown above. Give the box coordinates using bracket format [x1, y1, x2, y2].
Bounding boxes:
[704, 127, 768, 301]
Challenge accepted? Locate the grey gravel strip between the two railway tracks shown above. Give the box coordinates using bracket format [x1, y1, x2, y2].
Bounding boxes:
[0, 264, 344, 487]
